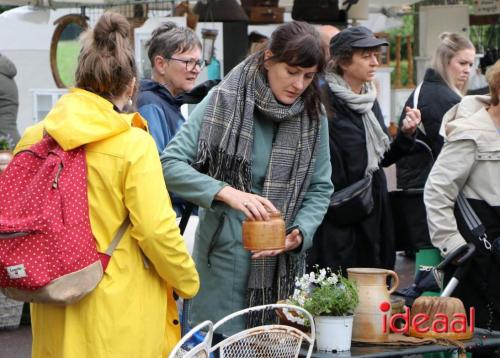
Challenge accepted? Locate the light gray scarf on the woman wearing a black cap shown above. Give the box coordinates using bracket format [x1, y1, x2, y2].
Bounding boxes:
[325, 73, 390, 175]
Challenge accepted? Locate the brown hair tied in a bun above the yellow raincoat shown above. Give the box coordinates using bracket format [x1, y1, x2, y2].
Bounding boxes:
[75, 11, 137, 101]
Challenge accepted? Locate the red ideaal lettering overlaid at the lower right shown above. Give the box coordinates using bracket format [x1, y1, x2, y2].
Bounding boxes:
[379, 302, 476, 334]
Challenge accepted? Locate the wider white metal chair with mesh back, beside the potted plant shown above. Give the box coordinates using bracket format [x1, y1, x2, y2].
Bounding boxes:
[210, 303, 316, 358]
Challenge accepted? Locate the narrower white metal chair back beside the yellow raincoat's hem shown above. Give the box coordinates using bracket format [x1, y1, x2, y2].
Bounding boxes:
[168, 321, 214, 358]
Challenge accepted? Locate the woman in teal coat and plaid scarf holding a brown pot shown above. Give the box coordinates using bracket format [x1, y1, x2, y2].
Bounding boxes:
[161, 21, 333, 340]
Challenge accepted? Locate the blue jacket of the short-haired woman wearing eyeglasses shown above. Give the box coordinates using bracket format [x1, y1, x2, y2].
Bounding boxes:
[137, 80, 186, 153]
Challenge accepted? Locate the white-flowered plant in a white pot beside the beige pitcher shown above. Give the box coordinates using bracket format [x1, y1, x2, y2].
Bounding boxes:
[288, 266, 359, 352]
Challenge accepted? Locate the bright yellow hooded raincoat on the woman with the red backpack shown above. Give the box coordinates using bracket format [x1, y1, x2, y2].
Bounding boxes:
[16, 89, 199, 358]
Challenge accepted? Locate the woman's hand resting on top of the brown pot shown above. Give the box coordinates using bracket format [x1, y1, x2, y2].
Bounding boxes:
[215, 185, 278, 220]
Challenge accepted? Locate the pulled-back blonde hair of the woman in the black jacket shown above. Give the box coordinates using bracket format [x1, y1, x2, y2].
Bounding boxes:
[431, 32, 475, 96]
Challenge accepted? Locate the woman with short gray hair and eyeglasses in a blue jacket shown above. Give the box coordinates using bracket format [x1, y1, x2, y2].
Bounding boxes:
[137, 22, 204, 153]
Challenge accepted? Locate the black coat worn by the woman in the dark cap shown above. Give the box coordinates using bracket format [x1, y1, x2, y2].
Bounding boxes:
[307, 92, 414, 270]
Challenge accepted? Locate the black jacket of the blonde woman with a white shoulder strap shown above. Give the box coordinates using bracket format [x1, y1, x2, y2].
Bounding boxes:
[396, 68, 461, 189]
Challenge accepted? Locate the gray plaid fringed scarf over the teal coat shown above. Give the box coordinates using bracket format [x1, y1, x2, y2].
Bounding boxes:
[193, 54, 320, 318]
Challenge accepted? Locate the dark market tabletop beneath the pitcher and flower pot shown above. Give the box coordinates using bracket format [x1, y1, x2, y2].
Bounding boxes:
[300, 328, 500, 358]
